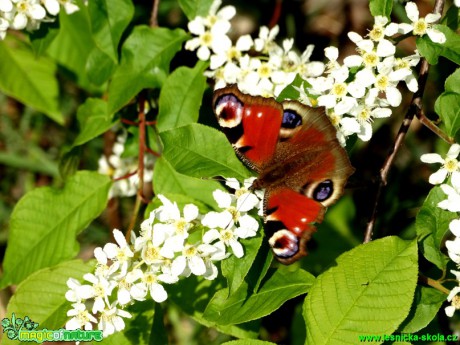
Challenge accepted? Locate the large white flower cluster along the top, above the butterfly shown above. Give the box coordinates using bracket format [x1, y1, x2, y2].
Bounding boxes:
[185, 0, 446, 145]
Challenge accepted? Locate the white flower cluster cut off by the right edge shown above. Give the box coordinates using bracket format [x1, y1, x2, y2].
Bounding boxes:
[420, 144, 460, 317]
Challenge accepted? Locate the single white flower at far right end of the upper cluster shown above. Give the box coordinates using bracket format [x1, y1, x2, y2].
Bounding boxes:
[399, 2, 446, 44]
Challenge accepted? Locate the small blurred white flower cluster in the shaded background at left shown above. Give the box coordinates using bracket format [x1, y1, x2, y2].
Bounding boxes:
[98, 132, 155, 198]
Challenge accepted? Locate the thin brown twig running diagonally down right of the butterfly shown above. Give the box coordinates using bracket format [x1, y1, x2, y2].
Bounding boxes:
[363, 0, 445, 243]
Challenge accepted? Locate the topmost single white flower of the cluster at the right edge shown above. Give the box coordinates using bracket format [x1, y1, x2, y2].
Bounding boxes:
[420, 144, 460, 184]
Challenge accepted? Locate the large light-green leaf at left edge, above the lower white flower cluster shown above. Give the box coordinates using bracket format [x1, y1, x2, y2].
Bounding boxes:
[2, 171, 111, 286]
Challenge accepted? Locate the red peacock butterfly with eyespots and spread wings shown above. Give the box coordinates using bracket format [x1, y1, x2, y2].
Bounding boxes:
[212, 85, 354, 264]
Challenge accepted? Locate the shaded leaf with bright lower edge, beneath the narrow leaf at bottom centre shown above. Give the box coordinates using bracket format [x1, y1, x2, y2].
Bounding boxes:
[166, 276, 260, 338]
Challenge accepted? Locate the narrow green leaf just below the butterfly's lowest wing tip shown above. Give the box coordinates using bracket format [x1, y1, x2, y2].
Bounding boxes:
[203, 266, 315, 325]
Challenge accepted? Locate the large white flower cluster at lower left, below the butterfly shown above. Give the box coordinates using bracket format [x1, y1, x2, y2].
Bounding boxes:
[66, 179, 261, 336]
